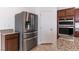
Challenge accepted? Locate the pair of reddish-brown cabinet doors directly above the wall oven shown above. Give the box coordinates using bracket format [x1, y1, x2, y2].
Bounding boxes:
[57, 8, 75, 17]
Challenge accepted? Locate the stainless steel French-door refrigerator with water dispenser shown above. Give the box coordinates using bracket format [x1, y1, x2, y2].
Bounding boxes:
[15, 12, 38, 51]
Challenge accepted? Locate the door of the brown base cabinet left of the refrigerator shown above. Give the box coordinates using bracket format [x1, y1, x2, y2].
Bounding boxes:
[5, 38, 18, 51]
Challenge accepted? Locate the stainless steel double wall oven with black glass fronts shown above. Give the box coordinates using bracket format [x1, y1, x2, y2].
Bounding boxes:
[58, 18, 74, 36]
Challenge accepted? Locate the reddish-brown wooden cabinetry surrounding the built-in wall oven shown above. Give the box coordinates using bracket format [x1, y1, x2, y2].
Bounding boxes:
[57, 8, 79, 37]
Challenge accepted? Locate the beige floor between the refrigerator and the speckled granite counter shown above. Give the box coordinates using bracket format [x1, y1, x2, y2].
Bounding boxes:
[31, 44, 57, 51]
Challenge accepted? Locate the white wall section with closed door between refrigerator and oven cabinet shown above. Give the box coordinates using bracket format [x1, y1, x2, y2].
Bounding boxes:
[35, 7, 57, 44]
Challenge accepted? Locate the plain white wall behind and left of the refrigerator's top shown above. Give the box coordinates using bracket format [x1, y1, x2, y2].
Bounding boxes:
[0, 7, 34, 29]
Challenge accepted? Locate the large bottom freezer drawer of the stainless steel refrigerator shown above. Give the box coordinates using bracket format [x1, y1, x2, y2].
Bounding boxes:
[23, 37, 37, 51]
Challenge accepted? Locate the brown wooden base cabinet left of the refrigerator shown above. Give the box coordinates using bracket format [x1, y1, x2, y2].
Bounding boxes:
[5, 33, 19, 51]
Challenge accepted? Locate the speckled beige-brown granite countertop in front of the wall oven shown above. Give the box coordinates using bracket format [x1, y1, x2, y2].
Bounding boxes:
[57, 36, 79, 51]
